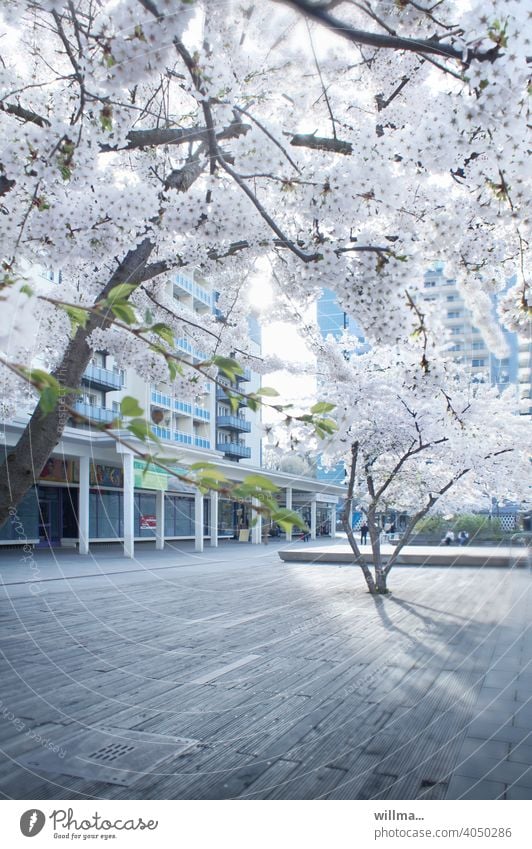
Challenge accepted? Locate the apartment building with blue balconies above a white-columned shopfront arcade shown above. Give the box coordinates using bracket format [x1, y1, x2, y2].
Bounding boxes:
[0, 273, 341, 557]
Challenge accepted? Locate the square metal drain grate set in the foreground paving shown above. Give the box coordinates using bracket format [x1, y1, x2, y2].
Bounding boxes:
[19, 728, 198, 787]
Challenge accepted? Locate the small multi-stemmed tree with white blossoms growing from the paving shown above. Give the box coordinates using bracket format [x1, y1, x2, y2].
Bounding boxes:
[314, 340, 532, 593]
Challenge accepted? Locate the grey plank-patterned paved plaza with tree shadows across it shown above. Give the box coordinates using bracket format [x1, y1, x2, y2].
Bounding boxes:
[0, 543, 532, 799]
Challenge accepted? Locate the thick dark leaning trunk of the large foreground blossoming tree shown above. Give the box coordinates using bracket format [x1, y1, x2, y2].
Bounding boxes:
[0, 239, 153, 527]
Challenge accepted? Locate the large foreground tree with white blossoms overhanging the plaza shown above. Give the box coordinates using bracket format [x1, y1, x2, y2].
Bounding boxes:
[0, 0, 528, 522]
